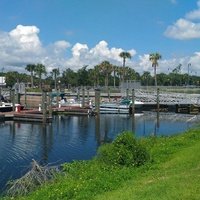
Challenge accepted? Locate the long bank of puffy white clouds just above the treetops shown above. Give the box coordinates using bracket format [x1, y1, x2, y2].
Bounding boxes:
[0, 22, 200, 74]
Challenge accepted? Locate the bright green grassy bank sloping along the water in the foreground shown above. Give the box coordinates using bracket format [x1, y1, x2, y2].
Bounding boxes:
[1, 130, 200, 200]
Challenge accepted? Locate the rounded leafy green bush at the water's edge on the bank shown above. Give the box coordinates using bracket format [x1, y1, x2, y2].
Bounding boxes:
[97, 132, 150, 166]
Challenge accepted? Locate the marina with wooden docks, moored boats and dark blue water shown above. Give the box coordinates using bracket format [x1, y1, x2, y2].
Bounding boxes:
[0, 89, 199, 191]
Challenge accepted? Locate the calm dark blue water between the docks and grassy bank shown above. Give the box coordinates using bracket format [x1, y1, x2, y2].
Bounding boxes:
[0, 113, 197, 190]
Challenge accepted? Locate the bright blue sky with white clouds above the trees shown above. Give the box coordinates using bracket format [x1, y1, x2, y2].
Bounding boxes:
[0, 0, 200, 75]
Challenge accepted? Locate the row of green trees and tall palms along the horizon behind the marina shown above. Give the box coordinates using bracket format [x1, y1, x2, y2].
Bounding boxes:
[0, 52, 200, 88]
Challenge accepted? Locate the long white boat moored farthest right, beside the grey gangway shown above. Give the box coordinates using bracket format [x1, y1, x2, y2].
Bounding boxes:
[97, 99, 143, 114]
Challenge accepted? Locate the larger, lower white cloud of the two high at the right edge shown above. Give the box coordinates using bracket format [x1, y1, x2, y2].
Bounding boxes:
[164, 18, 200, 40]
